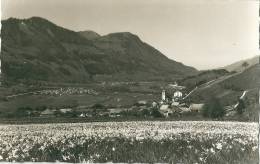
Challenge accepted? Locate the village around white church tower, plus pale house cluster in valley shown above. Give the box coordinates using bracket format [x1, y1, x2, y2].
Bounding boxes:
[15, 82, 209, 118]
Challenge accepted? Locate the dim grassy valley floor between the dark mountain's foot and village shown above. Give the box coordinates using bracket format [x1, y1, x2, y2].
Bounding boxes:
[0, 82, 164, 113]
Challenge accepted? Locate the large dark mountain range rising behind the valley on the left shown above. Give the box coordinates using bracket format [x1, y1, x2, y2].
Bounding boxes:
[1, 17, 197, 83]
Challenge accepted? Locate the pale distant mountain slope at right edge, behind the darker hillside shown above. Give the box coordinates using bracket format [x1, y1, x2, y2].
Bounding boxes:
[222, 56, 259, 72]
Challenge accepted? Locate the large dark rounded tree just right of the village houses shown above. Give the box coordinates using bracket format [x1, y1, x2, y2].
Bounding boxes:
[202, 97, 225, 118]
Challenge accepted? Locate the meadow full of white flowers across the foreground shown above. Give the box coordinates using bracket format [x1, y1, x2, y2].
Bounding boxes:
[0, 121, 259, 164]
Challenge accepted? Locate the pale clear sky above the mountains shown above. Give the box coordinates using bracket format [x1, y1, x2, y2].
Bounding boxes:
[1, 0, 259, 70]
